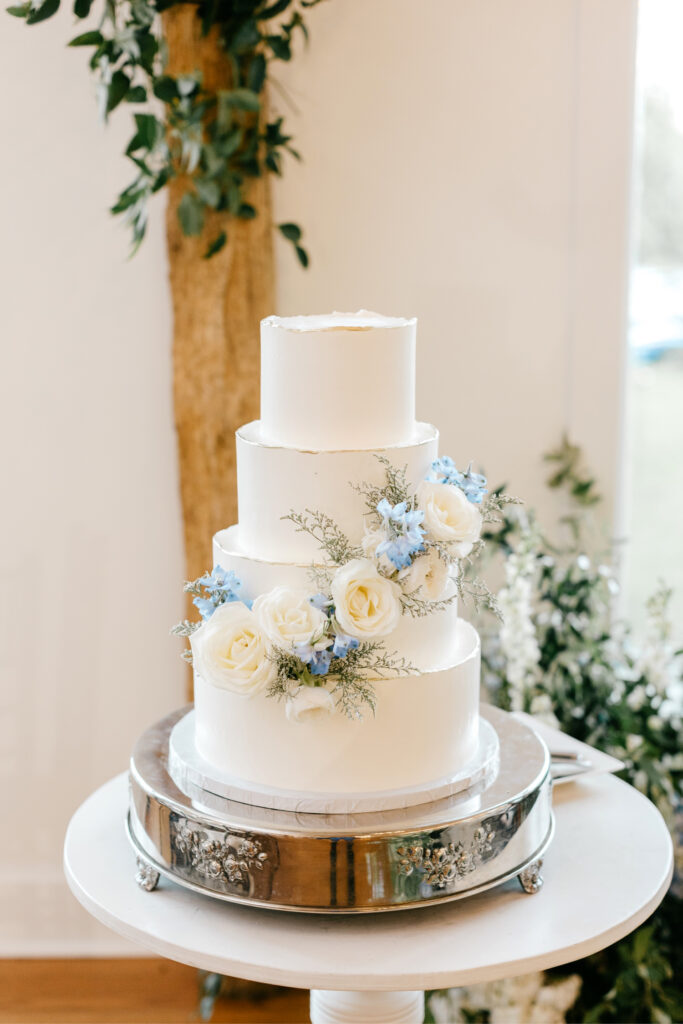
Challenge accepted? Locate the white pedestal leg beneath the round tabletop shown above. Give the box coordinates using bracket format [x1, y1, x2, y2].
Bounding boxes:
[310, 988, 425, 1024]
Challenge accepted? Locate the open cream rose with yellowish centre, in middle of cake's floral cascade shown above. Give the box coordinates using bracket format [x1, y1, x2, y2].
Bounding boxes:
[332, 558, 401, 640]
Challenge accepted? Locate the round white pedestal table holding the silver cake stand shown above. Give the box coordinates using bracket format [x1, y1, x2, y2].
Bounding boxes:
[65, 773, 673, 1024]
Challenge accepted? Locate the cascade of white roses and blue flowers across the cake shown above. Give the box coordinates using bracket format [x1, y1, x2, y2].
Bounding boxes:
[171, 456, 515, 722]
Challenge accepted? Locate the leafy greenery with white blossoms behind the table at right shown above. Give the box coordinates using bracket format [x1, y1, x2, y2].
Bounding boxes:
[461, 440, 683, 1024]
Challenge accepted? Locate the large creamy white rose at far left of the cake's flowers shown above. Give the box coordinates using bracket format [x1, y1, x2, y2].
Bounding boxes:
[189, 601, 276, 696]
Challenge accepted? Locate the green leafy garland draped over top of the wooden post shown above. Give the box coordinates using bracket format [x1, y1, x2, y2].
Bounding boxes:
[7, 0, 321, 260]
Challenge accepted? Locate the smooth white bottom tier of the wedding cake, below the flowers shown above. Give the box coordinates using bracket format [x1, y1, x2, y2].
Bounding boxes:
[195, 620, 480, 796]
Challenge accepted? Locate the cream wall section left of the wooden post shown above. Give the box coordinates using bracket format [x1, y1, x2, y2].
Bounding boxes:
[0, 11, 184, 955]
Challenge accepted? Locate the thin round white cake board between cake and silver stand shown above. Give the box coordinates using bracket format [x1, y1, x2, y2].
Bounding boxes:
[168, 711, 500, 814]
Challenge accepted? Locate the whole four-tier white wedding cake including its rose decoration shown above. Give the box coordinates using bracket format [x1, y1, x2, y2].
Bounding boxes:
[175, 311, 487, 807]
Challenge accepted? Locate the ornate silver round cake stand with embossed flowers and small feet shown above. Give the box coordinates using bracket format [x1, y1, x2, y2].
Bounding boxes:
[128, 707, 553, 913]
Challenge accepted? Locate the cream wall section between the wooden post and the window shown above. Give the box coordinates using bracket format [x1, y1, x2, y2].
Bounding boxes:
[274, 0, 635, 528]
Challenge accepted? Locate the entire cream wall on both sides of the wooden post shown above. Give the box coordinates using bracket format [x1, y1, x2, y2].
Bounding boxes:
[0, 0, 635, 955]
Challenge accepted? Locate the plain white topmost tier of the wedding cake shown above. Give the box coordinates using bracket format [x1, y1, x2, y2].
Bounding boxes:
[261, 309, 417, 451]
